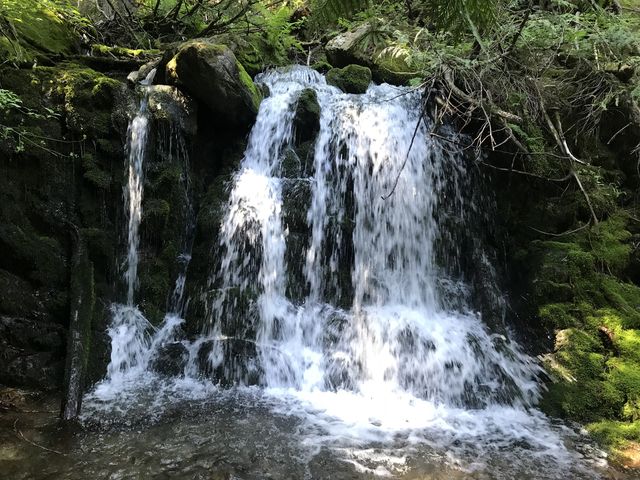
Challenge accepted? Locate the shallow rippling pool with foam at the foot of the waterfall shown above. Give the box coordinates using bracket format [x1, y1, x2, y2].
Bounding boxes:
[0, 382, 631, 480]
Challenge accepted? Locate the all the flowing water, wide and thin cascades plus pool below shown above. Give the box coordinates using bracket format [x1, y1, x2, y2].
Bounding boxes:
[8, 67, 620, 479]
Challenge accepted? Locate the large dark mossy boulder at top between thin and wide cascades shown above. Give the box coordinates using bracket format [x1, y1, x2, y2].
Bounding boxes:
[165, 40, 261, 127]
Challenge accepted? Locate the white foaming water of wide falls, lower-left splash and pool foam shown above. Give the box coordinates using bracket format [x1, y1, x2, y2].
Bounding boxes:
[88, 68, 608, 478]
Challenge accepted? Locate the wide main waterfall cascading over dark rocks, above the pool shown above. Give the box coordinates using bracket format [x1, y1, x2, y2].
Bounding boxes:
[202, 68, 538, 406]
